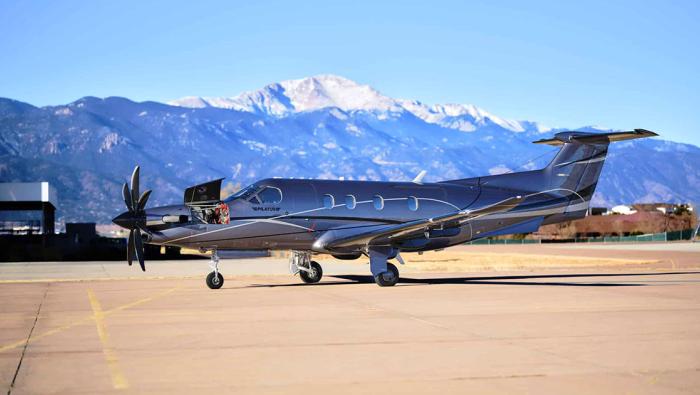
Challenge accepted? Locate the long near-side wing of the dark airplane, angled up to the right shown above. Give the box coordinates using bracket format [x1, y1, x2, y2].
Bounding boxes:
[319, 196, 525, 250]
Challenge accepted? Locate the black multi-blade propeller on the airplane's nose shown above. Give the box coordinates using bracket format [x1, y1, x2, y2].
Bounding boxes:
[112, 166, 151, 272]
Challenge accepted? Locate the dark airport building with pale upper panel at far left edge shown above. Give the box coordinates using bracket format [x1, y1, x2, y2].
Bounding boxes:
[0, 182, 58, 234]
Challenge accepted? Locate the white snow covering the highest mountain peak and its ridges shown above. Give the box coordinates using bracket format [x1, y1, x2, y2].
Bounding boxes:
[168, 74, 532, 132]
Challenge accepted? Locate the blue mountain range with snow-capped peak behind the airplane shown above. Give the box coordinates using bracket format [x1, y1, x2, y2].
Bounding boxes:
[0, 75, 700, 223]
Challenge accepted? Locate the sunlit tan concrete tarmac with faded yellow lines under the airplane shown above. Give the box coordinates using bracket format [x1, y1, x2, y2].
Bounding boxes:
[0, 243, 700, 394]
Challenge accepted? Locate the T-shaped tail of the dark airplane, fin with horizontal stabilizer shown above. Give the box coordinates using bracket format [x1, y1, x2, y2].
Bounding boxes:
[534, 129, 657, 211]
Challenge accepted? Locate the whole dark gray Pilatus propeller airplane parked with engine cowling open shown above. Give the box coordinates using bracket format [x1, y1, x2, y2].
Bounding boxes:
[113, 129, 657, 289]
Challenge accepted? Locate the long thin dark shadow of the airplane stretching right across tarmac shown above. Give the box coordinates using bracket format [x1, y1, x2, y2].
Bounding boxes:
[249, 272, 700, 287]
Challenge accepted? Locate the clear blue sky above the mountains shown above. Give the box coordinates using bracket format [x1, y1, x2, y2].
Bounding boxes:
[0, 0, 700, 145]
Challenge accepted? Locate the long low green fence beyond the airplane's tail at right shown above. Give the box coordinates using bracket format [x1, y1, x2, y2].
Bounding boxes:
[466, 229, 695, 245]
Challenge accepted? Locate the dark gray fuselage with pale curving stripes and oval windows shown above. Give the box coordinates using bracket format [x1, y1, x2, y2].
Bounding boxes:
[147, 171, 587, 254]
